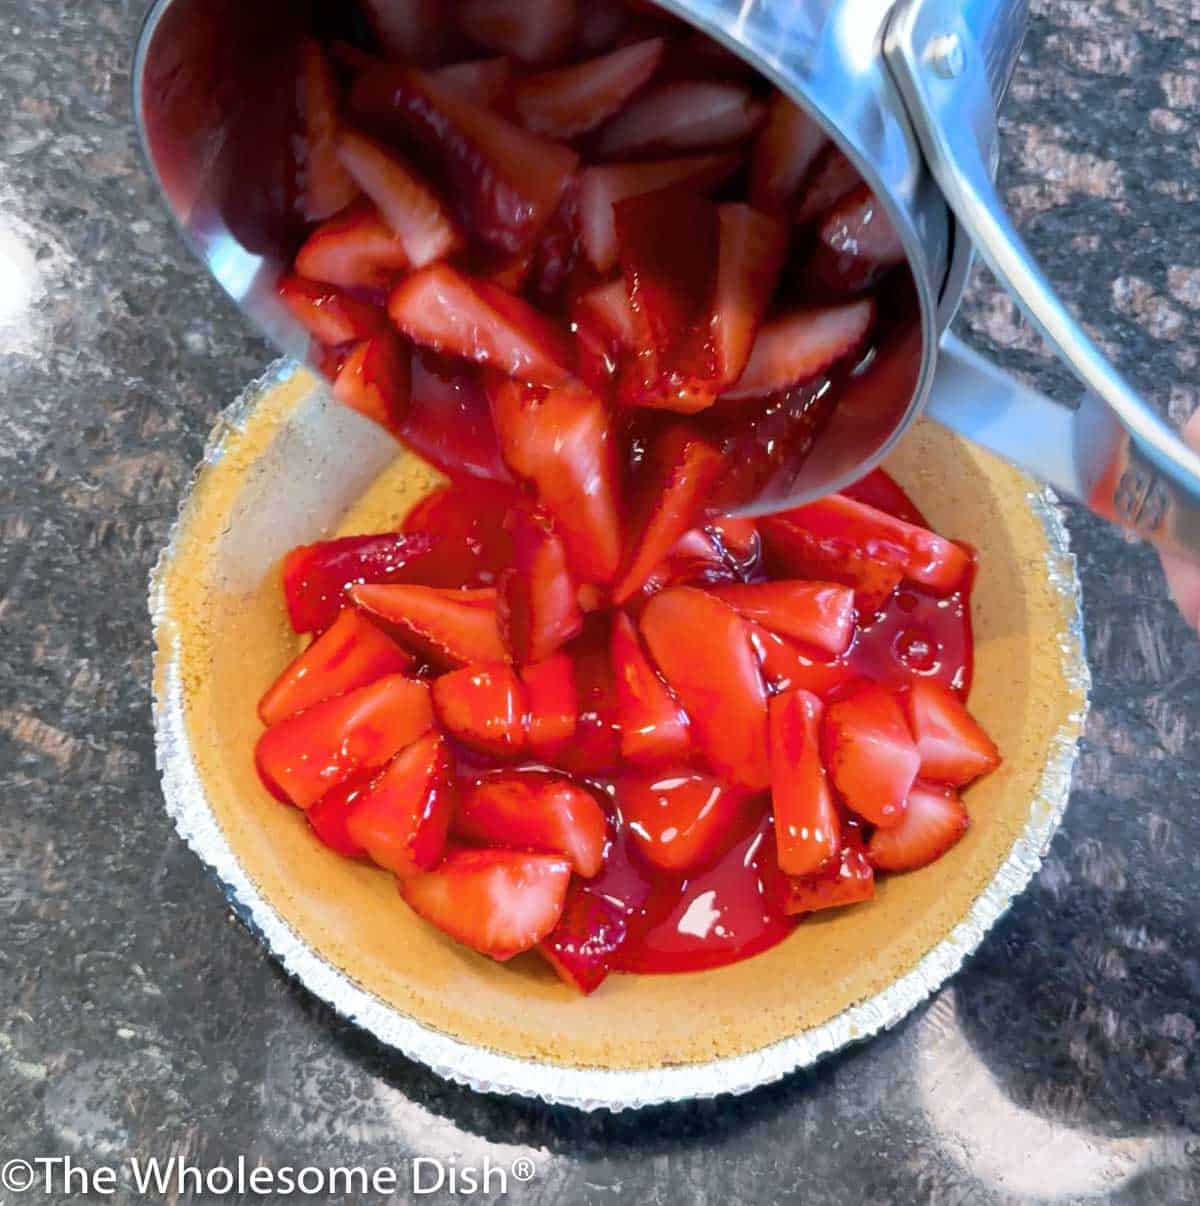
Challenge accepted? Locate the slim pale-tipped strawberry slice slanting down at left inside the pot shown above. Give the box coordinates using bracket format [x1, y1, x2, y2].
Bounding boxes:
[338, 130, 463, 268]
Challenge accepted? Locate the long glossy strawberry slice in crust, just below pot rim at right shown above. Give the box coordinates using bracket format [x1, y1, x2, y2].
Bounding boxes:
[780, 494, 971, 591]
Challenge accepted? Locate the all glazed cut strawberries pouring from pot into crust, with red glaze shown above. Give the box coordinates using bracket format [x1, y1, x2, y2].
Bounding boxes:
[246, 0, 999, 993]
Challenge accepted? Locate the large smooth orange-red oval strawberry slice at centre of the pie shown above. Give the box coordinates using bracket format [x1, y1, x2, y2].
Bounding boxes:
[642, 586, 771, 791]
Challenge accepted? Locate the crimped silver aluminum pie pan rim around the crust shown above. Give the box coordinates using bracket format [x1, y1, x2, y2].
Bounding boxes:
[150, 361, 1090, 1111]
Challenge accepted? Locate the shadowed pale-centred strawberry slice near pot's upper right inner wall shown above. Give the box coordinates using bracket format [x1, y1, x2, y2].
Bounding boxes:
[596, 80, 765, 157]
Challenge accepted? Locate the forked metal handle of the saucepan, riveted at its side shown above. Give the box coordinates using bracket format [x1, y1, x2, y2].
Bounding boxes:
[885, 0, 1200, 561]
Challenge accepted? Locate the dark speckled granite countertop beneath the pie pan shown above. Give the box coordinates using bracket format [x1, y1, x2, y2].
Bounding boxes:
[0, 0, 1200, 1206]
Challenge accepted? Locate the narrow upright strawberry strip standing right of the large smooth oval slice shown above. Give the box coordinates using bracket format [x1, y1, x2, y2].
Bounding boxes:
[768, 690, 842, 876]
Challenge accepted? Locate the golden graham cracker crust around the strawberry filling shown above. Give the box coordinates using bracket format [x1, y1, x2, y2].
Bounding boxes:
[157, 371, 1083, 1069]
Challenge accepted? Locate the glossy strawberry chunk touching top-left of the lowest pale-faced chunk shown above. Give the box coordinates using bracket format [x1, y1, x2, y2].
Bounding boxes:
[345, 733, 455, 876]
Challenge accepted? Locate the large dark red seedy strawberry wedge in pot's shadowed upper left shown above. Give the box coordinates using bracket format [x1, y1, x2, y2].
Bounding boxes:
[351, 64, 579, 254]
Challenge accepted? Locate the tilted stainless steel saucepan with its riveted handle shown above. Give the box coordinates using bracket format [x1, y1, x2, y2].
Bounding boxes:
[134, 0, 1200, 560]
